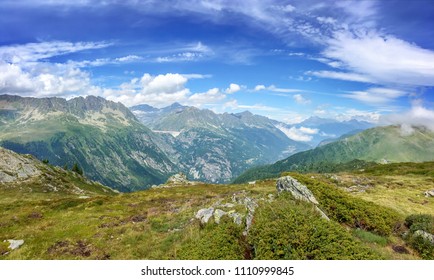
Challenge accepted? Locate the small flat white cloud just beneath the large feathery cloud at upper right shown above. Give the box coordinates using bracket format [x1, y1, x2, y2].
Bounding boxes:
[343, 88, 406, 105]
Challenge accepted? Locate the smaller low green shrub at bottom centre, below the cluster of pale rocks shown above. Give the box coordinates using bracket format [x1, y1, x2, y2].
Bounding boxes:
[178, 216, 246, 260]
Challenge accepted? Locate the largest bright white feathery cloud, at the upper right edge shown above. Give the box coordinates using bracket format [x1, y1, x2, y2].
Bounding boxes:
[324, 31, 434, 86]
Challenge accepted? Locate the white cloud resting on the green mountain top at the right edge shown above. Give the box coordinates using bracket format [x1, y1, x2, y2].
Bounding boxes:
[380, 102, 434, 132]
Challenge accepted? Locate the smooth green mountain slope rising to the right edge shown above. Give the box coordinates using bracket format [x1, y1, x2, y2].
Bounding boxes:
[235, 126, 434, 183]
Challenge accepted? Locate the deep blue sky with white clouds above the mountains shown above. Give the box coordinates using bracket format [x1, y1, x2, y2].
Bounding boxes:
[0, 0, 434, 126]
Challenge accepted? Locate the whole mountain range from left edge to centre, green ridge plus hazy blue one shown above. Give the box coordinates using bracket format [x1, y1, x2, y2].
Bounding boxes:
[0, 95, 309, 191]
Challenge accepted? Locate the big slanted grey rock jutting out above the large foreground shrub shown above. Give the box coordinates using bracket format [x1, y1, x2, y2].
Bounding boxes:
[276, 176, 330, 220]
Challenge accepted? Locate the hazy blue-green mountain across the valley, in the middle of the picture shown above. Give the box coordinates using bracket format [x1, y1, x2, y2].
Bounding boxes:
[131, 103, 309, 183]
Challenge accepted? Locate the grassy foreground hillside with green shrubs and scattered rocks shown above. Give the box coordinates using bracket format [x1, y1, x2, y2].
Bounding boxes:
[0, 151, 434, 259]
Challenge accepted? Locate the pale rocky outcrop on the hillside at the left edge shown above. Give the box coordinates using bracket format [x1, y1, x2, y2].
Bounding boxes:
[0, 148, 41, 183]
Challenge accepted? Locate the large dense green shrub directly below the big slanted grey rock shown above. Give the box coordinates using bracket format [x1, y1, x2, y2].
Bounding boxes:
[248, 195, 380, 260]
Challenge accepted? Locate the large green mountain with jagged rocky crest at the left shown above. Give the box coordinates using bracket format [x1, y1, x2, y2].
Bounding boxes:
[0, 95, 178, 191]
